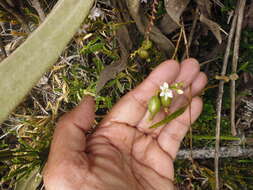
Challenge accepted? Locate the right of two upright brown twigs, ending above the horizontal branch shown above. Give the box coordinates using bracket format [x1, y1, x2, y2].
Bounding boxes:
[230, 0, 246, 136]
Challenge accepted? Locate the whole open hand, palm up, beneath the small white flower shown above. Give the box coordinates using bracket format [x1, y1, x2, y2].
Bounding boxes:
[43, 59, 207, 190]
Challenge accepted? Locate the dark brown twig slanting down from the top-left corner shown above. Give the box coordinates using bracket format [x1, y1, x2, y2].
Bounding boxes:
[0, 0, 30, 33]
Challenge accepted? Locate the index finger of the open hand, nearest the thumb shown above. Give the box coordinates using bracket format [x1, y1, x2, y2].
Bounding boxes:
[100, 60, 180, 126]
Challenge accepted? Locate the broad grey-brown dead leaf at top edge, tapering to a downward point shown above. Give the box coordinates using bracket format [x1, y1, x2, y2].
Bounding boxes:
[164, 0, 190, 26]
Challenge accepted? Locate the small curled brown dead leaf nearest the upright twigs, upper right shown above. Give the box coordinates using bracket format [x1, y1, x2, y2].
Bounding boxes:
[199, 14, 222, 44]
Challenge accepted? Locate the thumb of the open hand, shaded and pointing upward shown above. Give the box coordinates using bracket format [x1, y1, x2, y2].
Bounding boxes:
[49, 96, 95, 159]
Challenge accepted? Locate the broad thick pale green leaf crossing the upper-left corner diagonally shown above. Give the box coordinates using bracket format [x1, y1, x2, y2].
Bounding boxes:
[0, 0, 94, 123]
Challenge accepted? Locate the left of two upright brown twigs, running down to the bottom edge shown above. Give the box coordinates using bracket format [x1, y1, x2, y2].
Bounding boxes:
[214, 6, 237, 190]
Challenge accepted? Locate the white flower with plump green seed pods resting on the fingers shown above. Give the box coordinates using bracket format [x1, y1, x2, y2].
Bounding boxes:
[148, 82, 184, 120]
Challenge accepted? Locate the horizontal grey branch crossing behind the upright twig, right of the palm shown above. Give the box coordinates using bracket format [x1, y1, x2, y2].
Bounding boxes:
[177, 146, 253, 159]
